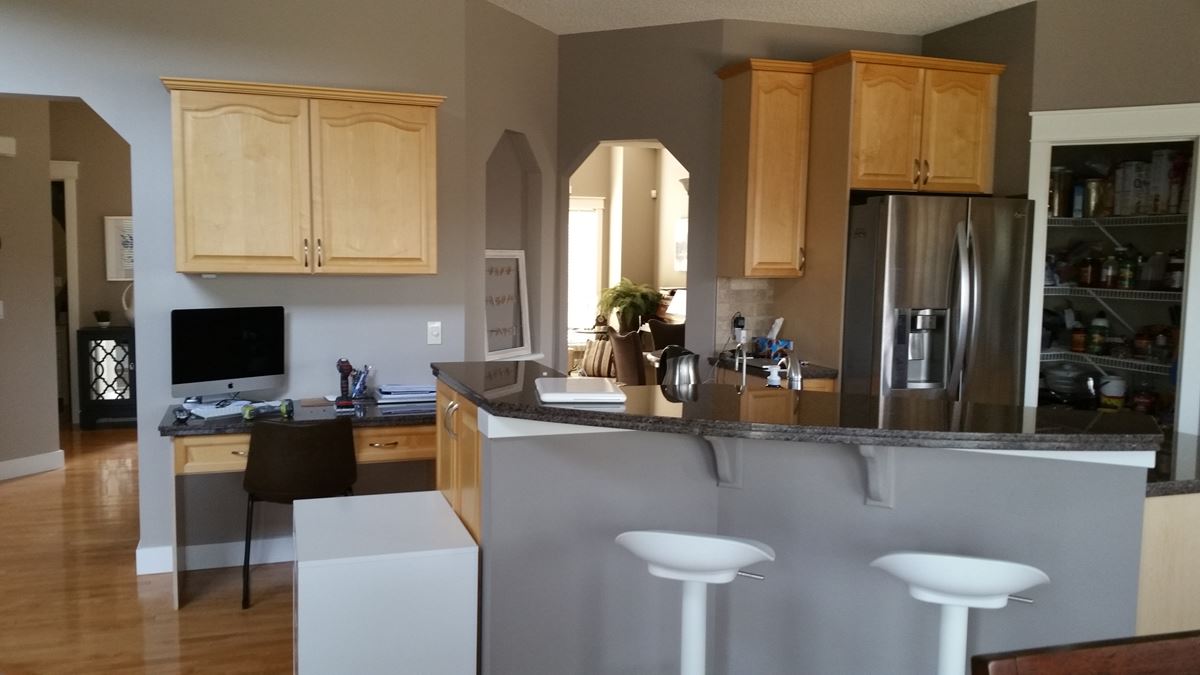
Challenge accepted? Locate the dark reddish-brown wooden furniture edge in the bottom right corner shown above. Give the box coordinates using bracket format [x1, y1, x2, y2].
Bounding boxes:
[971, 631, 1200, 675]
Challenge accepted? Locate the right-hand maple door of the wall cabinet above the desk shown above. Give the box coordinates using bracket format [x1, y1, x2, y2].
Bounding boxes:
[311, 100, 437, 274]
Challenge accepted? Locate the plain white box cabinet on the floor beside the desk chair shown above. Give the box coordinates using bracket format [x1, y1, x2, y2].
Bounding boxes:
[293, 491, 479, 675]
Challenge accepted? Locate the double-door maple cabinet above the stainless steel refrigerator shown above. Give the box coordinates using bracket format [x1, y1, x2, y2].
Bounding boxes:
[814, 52, 1004, 192]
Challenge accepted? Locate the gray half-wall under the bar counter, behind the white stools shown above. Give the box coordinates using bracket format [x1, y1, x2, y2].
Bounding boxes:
[482, 432, 1145, 675]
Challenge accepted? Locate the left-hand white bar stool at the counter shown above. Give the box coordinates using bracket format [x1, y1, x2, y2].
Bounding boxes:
[617, 530, 775, 675]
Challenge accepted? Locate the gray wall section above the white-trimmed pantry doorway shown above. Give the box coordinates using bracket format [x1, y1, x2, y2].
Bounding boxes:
[1033, 0, 1200, 110]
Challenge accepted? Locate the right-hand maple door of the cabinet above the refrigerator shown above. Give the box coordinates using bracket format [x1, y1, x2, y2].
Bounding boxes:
[920, 70, 998, 192]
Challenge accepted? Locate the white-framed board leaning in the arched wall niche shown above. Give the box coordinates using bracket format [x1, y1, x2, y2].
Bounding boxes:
[484, 250, 532, 360]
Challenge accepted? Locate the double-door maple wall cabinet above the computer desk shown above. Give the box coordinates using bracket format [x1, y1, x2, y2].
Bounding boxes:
[162, 78, 443, 274]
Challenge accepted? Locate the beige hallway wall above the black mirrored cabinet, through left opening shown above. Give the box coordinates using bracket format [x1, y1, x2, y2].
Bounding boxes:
[50, 101, 133, 325]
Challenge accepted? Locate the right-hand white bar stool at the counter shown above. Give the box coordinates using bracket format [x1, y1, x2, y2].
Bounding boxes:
[871, 551, 1050, 675]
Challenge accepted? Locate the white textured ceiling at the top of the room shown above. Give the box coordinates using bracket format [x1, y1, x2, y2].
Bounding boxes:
[491, 0, 1030, 35]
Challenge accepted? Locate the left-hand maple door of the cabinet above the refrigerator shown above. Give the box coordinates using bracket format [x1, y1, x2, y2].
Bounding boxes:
[850, 62, 925, 190]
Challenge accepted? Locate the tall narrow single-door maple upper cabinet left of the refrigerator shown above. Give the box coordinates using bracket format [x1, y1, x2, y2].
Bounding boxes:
[718, 59, 812, 277]
